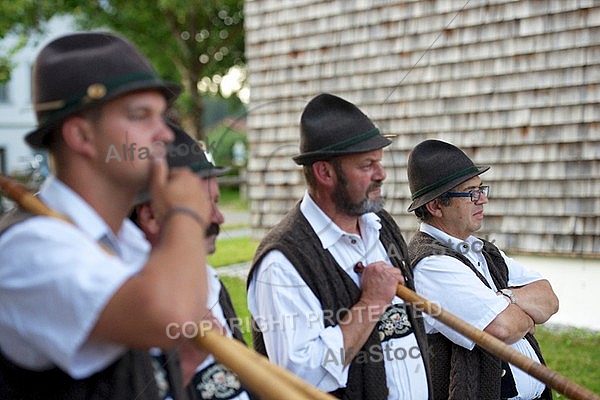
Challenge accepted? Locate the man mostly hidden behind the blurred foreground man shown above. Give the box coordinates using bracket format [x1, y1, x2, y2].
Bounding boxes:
[131, 122, 251, 400]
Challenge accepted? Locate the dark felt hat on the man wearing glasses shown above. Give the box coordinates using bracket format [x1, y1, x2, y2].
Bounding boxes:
[407, 139, 490, 212]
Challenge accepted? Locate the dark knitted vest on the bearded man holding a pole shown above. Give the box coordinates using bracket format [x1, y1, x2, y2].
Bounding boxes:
[248, 203, 431, 400]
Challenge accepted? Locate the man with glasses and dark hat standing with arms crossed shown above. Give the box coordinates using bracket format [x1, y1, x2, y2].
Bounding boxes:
[408, 140, 558, 400]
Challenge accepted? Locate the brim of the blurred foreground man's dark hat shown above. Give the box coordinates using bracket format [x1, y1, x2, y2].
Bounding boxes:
[25, 79, 181, 149]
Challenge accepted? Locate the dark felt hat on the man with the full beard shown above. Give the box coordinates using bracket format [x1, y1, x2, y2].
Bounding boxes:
[293, 93, 392, 165]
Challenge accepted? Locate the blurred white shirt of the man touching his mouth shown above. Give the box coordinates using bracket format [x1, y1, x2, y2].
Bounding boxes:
[0, 177, 150, 379]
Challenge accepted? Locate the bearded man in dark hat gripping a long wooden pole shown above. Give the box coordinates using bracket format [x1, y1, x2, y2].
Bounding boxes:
[248, 94, 430, 400]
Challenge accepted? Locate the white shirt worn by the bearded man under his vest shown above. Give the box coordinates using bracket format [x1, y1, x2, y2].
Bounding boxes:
[248, 193, 428, 400]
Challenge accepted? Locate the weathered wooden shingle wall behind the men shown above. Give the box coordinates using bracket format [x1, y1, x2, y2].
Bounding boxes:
[245, 0, 600, 256]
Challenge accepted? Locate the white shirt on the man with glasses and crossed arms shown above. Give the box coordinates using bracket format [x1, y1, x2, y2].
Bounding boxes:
[414, 223, 545, 400]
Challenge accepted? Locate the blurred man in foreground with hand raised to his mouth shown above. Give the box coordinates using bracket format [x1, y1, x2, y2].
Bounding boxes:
[0, 33, 210, 400]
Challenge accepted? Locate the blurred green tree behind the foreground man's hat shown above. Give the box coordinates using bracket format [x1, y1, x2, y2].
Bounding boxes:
[0, 0, 245, 138]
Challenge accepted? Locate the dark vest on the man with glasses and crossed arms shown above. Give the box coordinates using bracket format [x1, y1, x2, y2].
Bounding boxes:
[408, 232, 552, 400]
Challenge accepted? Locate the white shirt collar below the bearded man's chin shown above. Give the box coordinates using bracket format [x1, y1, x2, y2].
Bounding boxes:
[300, 191, 381, 249]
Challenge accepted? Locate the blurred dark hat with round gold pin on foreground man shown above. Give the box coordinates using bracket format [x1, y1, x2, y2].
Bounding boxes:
[25, 32, 181, 148]
